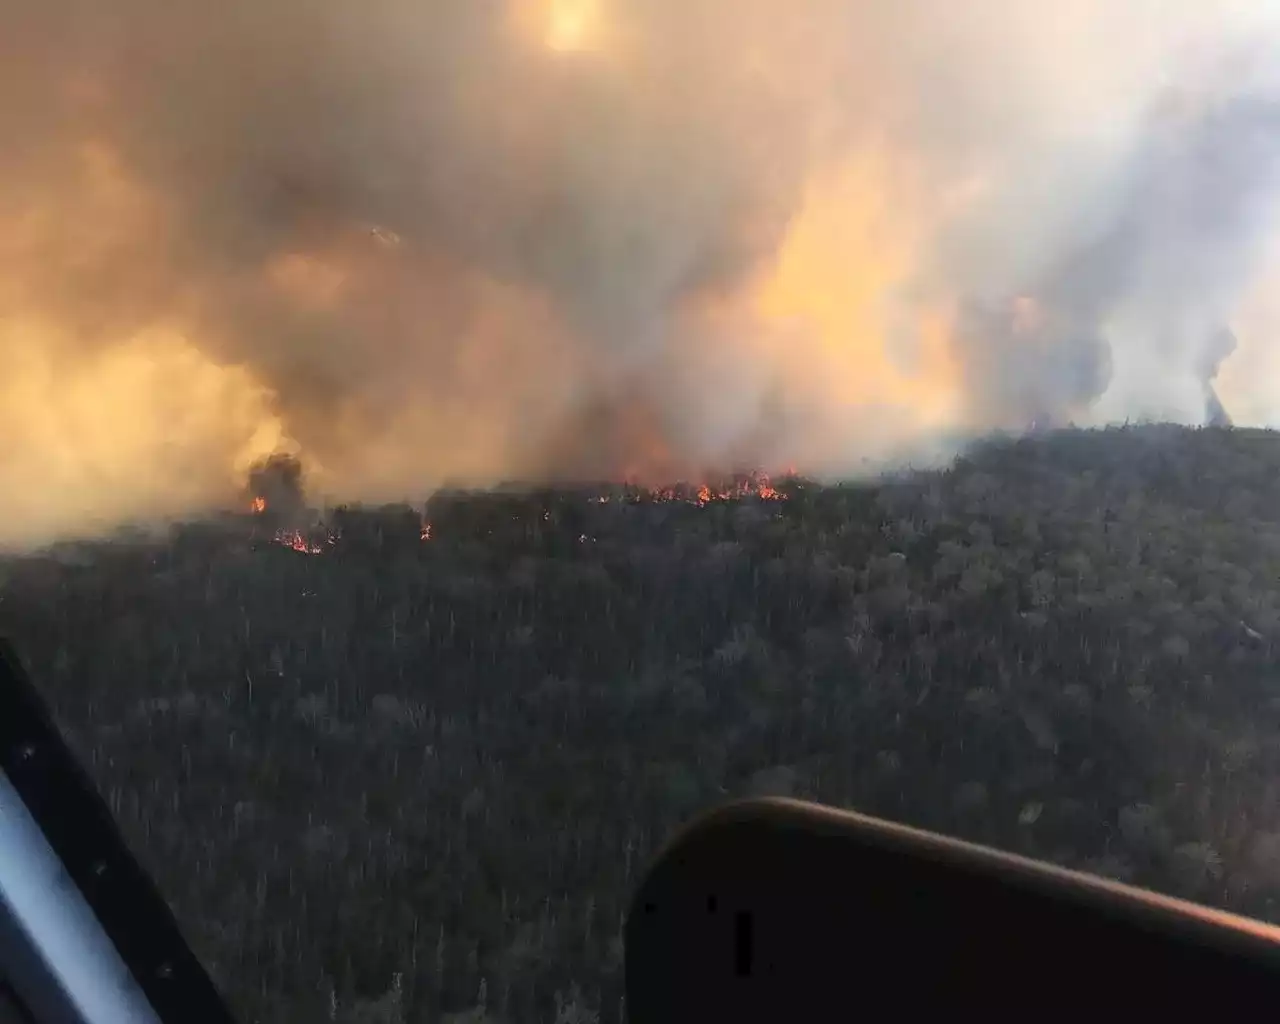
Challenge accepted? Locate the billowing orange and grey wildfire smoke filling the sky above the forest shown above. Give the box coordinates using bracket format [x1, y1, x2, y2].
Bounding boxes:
[0, 0, 1280, 544]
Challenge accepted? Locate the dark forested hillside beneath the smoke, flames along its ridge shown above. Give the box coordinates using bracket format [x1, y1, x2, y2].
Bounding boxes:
[0, 426, 1280, 1024]
